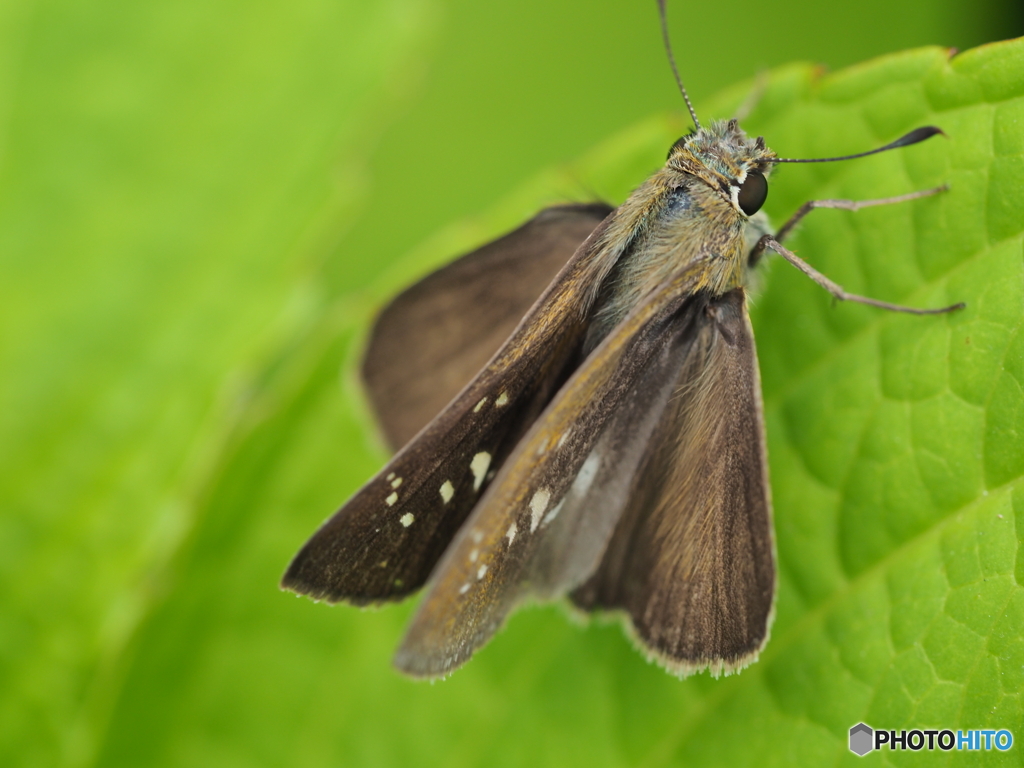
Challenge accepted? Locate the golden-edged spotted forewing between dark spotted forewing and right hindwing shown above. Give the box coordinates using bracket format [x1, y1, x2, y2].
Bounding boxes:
[395, 273, 712, 677]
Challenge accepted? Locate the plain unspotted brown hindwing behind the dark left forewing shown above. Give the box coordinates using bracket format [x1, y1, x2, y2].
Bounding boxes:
[362, 203, 612, 449]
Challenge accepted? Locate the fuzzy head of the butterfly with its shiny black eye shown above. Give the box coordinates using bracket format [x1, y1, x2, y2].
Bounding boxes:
[668, 120, 776, 216]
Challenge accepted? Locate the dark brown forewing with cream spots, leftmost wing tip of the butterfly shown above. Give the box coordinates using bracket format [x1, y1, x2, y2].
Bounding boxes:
[282, 207, 614, 604]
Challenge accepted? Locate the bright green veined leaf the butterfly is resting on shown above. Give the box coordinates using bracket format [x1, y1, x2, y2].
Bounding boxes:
[90, 41, 1024, 766]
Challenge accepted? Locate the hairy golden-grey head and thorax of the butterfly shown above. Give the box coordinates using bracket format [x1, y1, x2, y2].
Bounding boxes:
[587, 120, 775, 349]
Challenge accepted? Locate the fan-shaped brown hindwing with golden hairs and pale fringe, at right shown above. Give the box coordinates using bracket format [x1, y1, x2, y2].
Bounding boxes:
[572, 290, 775, 675]
